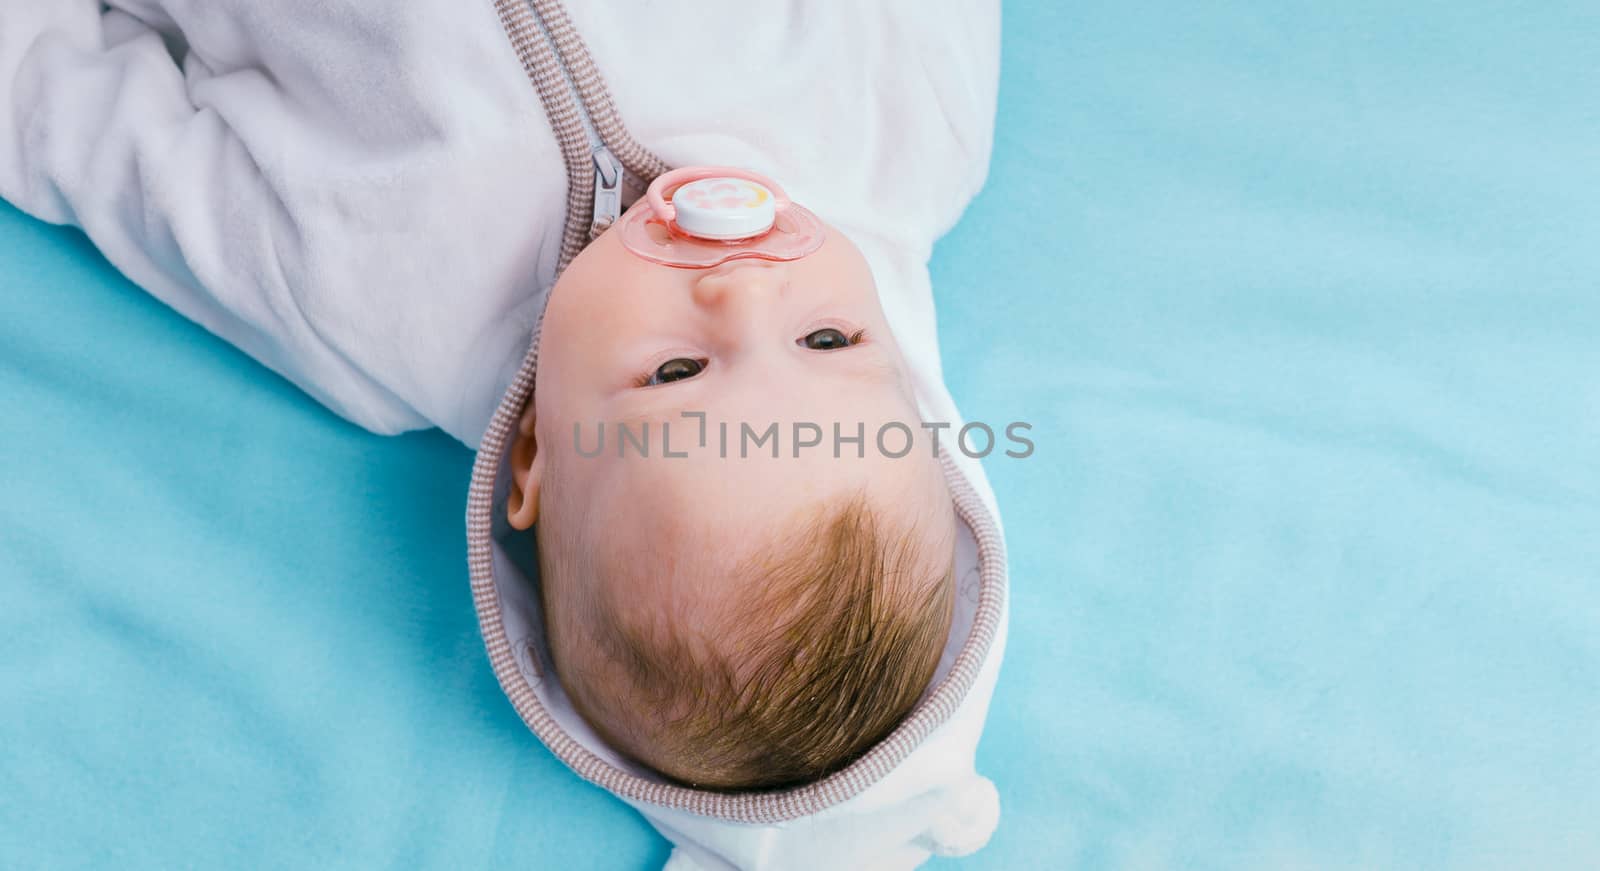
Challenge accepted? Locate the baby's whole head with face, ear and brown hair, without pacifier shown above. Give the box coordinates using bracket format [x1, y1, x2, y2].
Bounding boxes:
[507, 219, 955, 786]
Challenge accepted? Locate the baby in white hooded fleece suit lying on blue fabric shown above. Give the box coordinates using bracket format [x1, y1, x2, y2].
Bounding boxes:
[0, 0, 1005, 868]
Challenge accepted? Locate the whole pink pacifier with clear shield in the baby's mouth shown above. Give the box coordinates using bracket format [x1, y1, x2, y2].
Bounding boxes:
[616, 167, 827, 269]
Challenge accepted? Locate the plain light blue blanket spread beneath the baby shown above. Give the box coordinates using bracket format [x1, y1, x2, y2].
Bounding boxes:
[0, 0, 1600, 869]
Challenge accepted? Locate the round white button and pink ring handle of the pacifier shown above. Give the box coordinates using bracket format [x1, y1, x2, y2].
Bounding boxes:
[645, 167, 790, 240]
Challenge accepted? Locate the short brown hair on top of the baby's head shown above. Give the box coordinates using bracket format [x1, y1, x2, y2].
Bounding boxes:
[570, 496, 955, 791]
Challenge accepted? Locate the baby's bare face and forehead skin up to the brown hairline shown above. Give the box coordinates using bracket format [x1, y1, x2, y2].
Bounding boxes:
[512, 212, 949, 614]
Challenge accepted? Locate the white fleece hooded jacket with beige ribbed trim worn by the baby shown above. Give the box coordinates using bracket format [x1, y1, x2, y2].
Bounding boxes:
[0, 0, 1005, 868]
